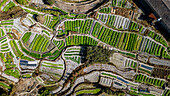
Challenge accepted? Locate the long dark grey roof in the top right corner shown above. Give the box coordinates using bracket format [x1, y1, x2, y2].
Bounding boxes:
[145, 0, 170, 33]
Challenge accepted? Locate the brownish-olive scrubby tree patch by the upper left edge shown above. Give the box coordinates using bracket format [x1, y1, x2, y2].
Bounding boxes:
[0, 6, 27, 20]
